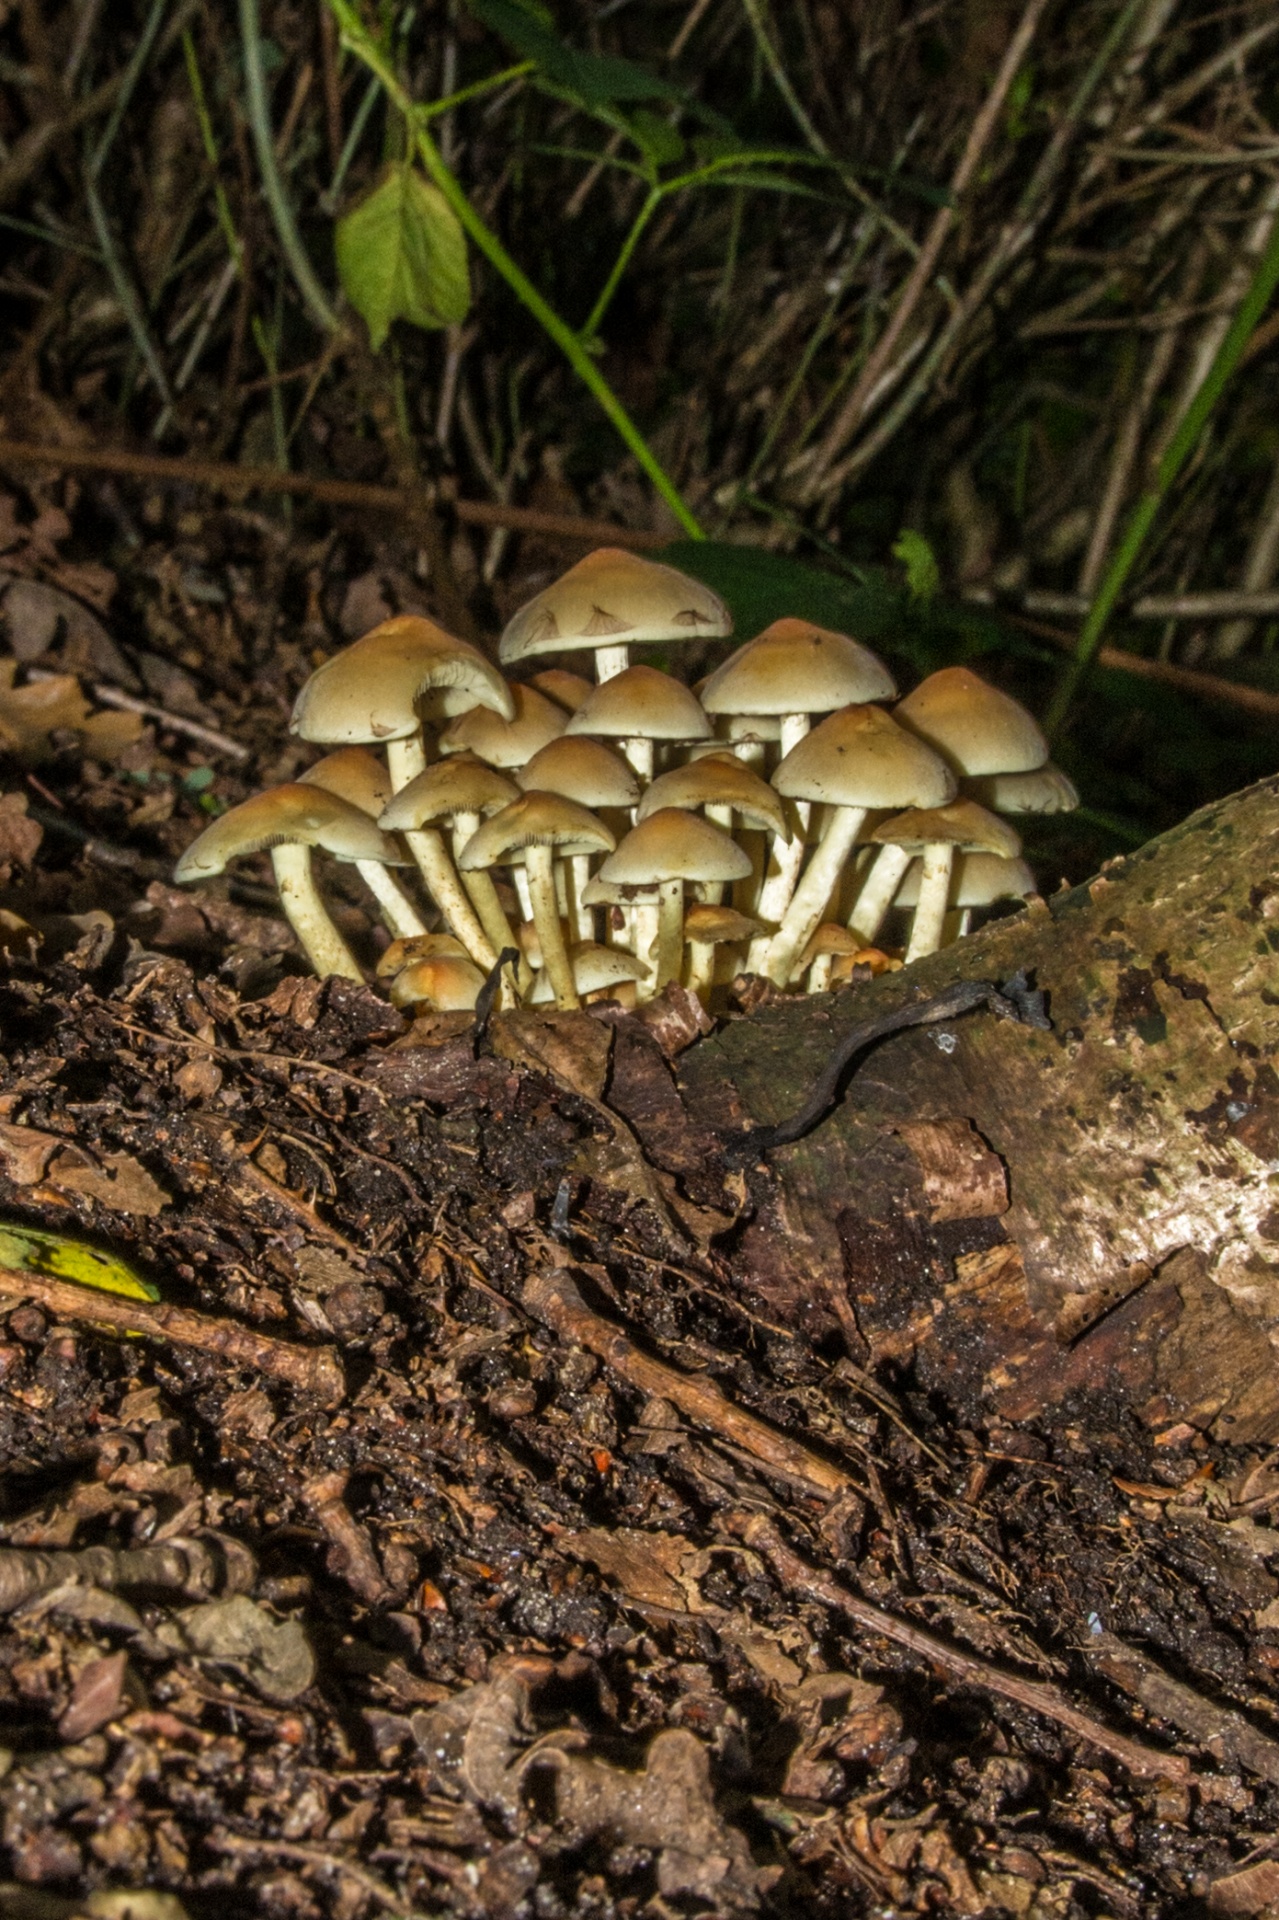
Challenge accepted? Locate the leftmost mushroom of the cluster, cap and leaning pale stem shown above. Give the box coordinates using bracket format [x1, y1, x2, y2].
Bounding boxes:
[173, 780, 401, 981]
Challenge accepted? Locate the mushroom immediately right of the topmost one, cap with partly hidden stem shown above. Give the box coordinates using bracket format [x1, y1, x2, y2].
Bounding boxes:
[701, 618, 897, 925]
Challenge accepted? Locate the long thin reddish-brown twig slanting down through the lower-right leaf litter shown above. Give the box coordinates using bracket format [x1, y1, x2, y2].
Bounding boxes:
[728, 1513, 1191, 1780]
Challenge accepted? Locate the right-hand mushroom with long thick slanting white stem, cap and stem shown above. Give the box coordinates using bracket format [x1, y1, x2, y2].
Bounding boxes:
[749, 707, 954, 987]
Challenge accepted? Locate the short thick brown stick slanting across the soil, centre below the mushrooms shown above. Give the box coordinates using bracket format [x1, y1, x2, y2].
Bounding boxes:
[522, 1271, 857, 1500]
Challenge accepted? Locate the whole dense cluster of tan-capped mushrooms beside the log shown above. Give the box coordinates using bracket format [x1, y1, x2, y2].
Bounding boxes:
[177, 547, 1077, 1010]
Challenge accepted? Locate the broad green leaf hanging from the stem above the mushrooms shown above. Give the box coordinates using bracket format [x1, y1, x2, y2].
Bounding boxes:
[334, 161, 471, 353]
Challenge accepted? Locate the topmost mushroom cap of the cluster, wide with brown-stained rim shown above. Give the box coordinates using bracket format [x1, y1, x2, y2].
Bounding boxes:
[497, 547, 734, 666]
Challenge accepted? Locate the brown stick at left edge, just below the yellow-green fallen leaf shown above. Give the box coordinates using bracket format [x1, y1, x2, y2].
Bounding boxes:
[0, 1267, 346, 1407]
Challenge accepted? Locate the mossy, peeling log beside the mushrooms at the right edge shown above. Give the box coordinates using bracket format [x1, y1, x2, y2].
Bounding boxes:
[678, 780, 1279, 1440]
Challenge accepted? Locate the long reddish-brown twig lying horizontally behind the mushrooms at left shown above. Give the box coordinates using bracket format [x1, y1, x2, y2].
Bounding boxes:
[0, 438, 670, 551]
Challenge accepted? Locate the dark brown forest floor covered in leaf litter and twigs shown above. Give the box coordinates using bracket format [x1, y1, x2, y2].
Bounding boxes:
[0, 490, 1279, 1920]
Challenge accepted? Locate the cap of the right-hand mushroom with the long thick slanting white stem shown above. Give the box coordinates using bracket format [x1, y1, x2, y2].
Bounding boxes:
[772, 707, 956, 806]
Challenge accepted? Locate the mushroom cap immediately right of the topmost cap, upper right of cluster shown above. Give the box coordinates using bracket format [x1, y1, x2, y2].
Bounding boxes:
[701, 618, 897, 714]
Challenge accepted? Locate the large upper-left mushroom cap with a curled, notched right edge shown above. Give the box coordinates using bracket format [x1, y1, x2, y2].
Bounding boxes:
[290, 614, 515, 745]
